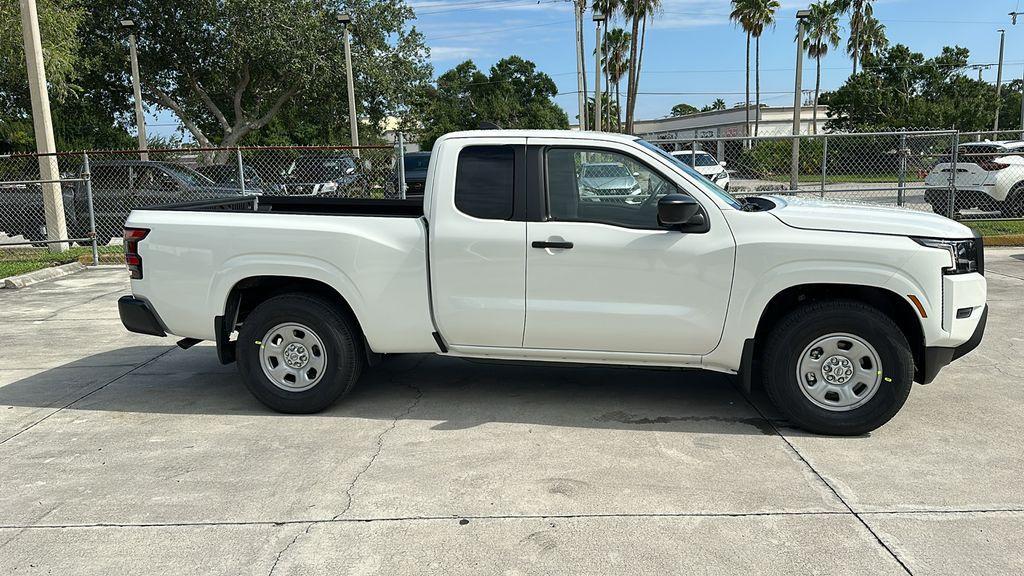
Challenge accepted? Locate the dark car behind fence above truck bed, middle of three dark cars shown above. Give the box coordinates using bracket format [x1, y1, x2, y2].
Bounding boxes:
[281, 154, 368, 196]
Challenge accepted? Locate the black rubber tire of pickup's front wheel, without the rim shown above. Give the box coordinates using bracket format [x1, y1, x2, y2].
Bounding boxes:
[762, 300, 913, 436]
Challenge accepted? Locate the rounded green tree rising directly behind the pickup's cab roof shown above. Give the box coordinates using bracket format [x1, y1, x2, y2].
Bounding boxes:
[414, 56, 569, 148]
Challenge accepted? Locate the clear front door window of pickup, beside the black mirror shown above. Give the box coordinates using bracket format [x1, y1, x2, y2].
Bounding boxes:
[547, 149, 676, 229]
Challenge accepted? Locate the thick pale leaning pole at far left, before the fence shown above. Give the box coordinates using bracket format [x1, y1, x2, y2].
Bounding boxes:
[22, 0, 68, 252]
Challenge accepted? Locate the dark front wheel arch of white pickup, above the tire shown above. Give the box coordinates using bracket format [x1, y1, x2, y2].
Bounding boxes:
[740, 283, 925, 392]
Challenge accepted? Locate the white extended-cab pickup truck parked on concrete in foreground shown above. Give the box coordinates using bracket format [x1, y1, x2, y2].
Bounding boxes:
[119, 130, 987, 435]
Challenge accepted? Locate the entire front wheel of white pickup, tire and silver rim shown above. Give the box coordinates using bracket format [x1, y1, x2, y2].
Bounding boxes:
[762, 300, 913, 436]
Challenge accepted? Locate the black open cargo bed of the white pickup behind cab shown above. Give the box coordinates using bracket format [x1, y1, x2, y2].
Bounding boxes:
[141, 196, 423, 218]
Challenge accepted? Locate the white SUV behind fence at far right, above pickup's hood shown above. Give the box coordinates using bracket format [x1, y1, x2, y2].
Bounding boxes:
[925, 140, 1024, 217]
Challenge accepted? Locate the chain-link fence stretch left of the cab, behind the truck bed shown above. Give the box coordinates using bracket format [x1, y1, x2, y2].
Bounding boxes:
[0, 142, 411, 278]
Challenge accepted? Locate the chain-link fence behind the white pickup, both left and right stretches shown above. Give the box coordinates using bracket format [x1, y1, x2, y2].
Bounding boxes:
[0, 130, 1024, 278]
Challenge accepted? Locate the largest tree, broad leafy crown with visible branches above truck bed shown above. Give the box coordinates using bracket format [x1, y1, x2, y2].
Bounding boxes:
[126, 0, 430, 156]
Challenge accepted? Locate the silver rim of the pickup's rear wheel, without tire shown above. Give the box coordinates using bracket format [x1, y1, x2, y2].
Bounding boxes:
[259, 322, 327, 392]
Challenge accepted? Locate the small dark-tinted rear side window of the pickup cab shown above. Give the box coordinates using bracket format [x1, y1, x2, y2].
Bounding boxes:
[455, 146, 515, 220]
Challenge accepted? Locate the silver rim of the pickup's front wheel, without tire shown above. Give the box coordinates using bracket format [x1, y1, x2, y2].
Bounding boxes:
[797, 333, 883, 412]
